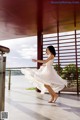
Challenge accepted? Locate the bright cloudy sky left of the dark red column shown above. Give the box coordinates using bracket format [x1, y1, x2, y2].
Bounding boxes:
[0, 36, 37, 68]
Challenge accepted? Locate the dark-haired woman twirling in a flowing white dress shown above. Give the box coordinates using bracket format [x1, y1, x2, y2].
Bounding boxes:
[22, 46, 67, 103]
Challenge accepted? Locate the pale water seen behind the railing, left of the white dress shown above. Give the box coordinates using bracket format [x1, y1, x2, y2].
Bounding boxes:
[5, 75, 34, 89]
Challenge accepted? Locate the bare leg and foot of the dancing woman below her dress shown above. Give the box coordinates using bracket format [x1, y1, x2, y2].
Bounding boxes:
[44, 84, 58, 103]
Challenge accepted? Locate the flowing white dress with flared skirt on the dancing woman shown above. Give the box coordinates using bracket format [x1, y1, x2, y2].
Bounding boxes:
[21, 60, 67, 94]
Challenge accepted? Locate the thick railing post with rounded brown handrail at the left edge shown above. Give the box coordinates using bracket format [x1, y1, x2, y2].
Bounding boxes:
[0, 46, 10, 112]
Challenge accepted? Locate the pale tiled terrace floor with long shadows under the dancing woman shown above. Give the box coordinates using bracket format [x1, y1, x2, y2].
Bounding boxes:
[5, 90, 80, 120]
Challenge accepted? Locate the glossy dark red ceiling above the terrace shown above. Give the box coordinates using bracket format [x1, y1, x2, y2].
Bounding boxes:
[0, 0, 80, 40]
